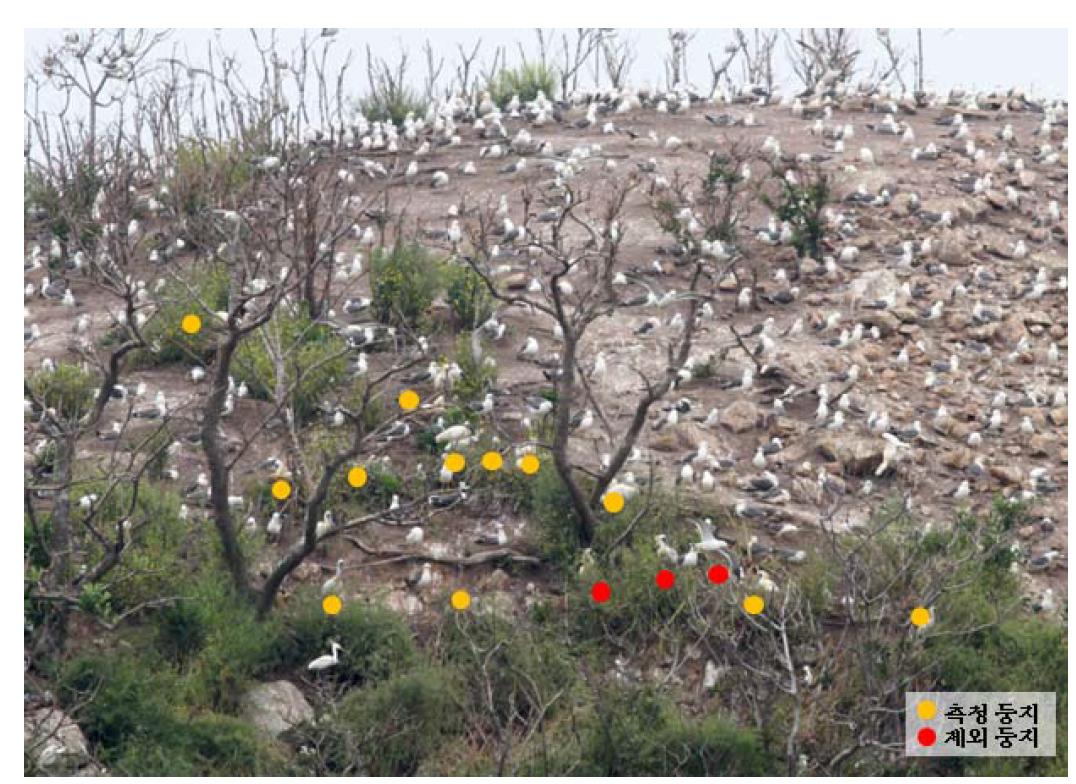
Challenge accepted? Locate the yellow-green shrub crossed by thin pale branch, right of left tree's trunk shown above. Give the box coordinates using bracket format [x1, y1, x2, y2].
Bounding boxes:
[232, 312, 348, 423]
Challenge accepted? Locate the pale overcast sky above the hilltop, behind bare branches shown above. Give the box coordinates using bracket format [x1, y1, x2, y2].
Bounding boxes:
[25, 29, 1068, 104]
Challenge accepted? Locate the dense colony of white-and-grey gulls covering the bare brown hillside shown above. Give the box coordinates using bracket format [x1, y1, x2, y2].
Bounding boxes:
[24, 79, 1067, 628]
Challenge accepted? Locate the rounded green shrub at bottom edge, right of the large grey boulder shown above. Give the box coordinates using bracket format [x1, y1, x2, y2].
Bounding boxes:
[337, 667, 466, 775]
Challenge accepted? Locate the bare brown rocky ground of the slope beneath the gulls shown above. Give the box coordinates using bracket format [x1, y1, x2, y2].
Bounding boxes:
[25, 88, 1067, 666]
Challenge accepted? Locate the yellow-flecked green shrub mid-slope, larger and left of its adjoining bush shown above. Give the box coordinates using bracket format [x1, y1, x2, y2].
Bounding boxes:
[370, 242, 441, 328]
